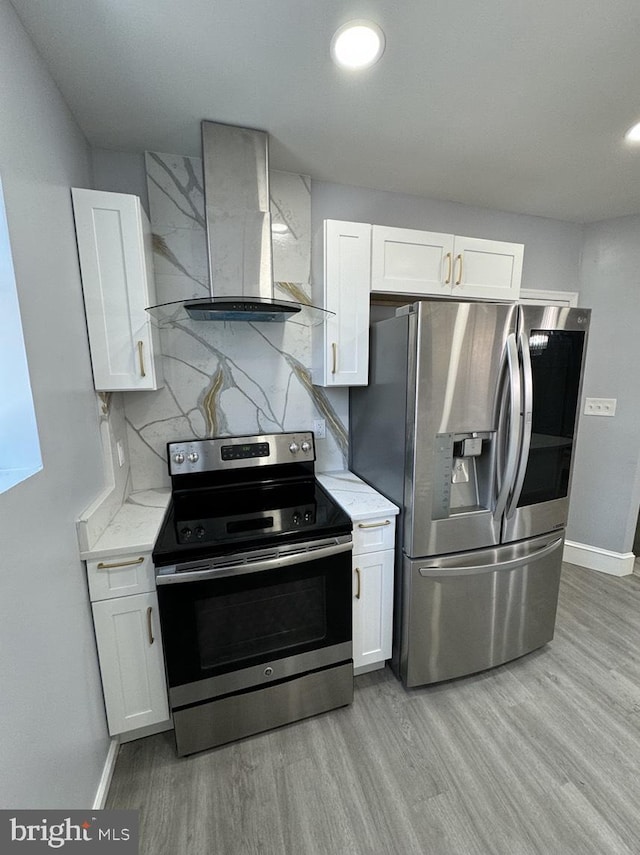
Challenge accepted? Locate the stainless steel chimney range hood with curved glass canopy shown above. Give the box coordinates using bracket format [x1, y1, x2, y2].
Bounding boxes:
[151, 121, 331, 324]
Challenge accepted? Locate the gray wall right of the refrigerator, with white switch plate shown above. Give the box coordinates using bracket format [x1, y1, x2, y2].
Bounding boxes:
[568, 212, 640, 553]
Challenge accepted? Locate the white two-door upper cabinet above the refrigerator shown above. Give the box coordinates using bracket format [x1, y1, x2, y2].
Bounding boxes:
[371, 226, 524, 300]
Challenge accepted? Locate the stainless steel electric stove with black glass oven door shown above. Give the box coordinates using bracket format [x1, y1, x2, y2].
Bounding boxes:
[153, 432, 353, 755]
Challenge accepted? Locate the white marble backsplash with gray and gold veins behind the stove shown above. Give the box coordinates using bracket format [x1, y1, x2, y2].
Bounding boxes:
[123, 152, 348, 491]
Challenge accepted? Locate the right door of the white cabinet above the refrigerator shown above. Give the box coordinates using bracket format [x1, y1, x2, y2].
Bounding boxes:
[452, 236, 524, 300]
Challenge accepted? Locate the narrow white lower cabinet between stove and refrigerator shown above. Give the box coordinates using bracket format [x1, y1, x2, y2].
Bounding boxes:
[353, 517, 395, 674]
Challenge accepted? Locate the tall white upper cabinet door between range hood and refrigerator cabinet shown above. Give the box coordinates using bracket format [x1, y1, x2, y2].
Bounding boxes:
[313, 220, 371, 386]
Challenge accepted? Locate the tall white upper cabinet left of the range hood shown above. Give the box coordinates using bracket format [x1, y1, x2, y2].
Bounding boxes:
[71, 188, 162, 391]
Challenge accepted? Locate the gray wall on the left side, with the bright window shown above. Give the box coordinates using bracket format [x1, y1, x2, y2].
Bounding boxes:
[0, 0, 109, 808]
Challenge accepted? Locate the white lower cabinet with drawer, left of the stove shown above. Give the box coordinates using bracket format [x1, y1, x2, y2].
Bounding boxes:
[87, 555, 169, 736]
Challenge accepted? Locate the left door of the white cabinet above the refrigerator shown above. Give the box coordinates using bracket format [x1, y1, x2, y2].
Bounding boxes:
[371, 226, 453, 296]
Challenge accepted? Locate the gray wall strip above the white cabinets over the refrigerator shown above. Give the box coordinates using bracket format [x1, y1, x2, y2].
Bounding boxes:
[311, 181, 582, 291]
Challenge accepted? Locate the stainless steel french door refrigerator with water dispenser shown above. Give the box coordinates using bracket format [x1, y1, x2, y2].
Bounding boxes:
[350, 300, 590, 686]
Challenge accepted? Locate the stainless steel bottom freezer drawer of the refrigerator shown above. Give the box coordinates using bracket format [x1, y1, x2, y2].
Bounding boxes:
[399, 532, 564, 686]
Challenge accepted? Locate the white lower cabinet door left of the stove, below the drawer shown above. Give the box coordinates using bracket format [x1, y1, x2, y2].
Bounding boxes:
[93, 592, 169, 736]
